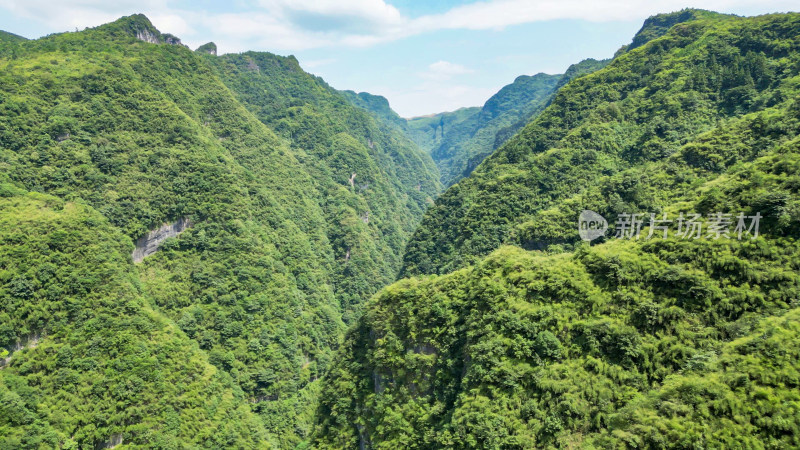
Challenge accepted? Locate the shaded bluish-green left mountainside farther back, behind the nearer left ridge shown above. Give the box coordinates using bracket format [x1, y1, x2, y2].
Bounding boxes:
[198, 52, 439, 322]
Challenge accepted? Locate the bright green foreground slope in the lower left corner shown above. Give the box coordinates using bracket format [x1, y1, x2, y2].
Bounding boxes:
[0, 183, 266, 450]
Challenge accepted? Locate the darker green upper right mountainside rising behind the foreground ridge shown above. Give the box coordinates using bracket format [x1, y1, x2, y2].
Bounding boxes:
[404, 10, 800, 275]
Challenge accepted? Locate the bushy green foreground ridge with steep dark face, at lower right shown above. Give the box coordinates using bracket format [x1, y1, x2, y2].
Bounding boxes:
[317, 239, 800, 449]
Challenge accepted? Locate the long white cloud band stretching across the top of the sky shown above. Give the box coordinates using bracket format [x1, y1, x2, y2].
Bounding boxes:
[0, 0, 797, 52]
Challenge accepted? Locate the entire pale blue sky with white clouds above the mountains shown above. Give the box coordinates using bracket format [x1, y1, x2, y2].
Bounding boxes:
[0, 0, 800, 117]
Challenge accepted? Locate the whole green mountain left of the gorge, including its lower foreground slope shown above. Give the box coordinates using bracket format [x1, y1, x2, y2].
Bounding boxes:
[0, 15, 439, 448]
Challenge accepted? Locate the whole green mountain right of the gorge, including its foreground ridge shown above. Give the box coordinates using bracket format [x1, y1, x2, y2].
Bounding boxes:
[315, 11, 800, 449]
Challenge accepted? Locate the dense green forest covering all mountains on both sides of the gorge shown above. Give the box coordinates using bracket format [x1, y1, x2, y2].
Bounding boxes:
[0, 9, 800, 450]
